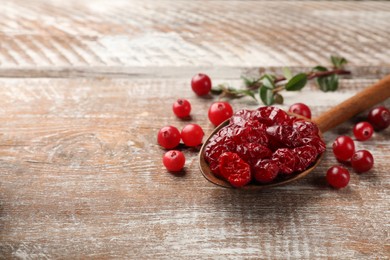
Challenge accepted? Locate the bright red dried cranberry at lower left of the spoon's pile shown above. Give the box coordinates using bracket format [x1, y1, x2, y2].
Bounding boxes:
[219, 152, 252, 188]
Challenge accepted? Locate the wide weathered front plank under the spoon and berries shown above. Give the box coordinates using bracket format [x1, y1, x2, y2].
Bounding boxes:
[0, 74, 390, 259]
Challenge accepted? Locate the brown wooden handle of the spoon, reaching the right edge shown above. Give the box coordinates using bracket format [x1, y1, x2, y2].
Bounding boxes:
[313, 75, 390, 133]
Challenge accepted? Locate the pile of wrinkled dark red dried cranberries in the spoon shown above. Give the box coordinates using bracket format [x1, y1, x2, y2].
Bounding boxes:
[205, 107, 326, 187]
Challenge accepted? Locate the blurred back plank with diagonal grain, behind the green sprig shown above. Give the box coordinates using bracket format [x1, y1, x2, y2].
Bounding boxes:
[0, 0, 390, 68]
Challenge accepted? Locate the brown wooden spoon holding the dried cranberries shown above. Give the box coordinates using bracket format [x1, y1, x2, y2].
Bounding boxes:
[199, 75, 390, 190]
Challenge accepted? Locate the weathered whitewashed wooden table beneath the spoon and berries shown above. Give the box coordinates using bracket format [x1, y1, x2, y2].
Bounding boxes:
[0, 0, 390, 259]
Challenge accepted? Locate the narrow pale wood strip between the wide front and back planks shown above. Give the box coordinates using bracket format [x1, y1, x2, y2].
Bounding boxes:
[0, 64, 390, 80]
